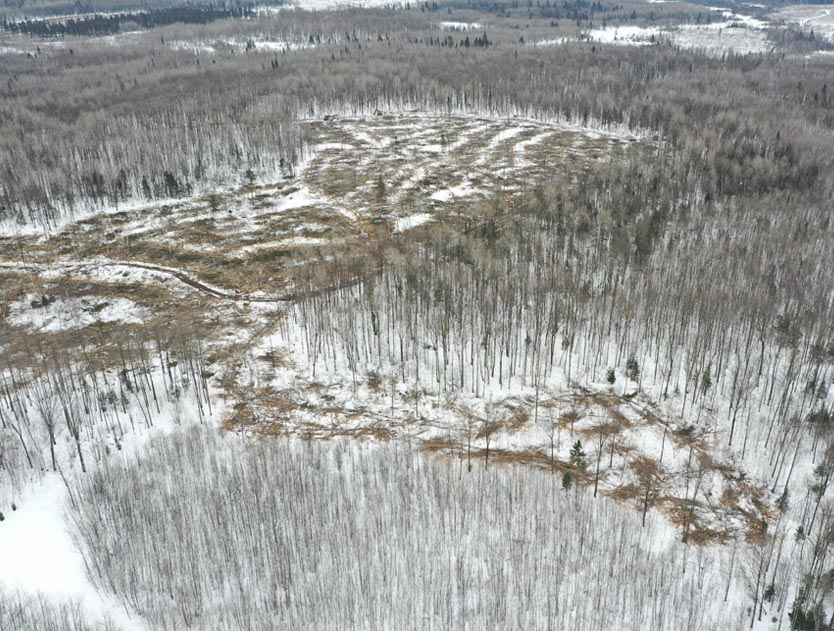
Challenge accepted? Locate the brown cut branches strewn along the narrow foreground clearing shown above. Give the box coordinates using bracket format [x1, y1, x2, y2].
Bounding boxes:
[219, 372, 773, 545]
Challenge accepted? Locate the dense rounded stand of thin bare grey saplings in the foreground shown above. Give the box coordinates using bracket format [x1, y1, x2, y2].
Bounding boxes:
[55, 432, 749, 631]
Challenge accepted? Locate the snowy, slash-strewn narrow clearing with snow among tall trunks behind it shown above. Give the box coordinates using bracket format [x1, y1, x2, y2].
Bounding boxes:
[253, 304, 774, 541]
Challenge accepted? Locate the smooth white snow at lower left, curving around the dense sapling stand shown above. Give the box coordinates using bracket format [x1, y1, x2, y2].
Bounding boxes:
[0, 346, 222, 631]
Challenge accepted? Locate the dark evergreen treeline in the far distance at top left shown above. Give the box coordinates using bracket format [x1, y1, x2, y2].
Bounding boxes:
[3, 5, 255, 37]
